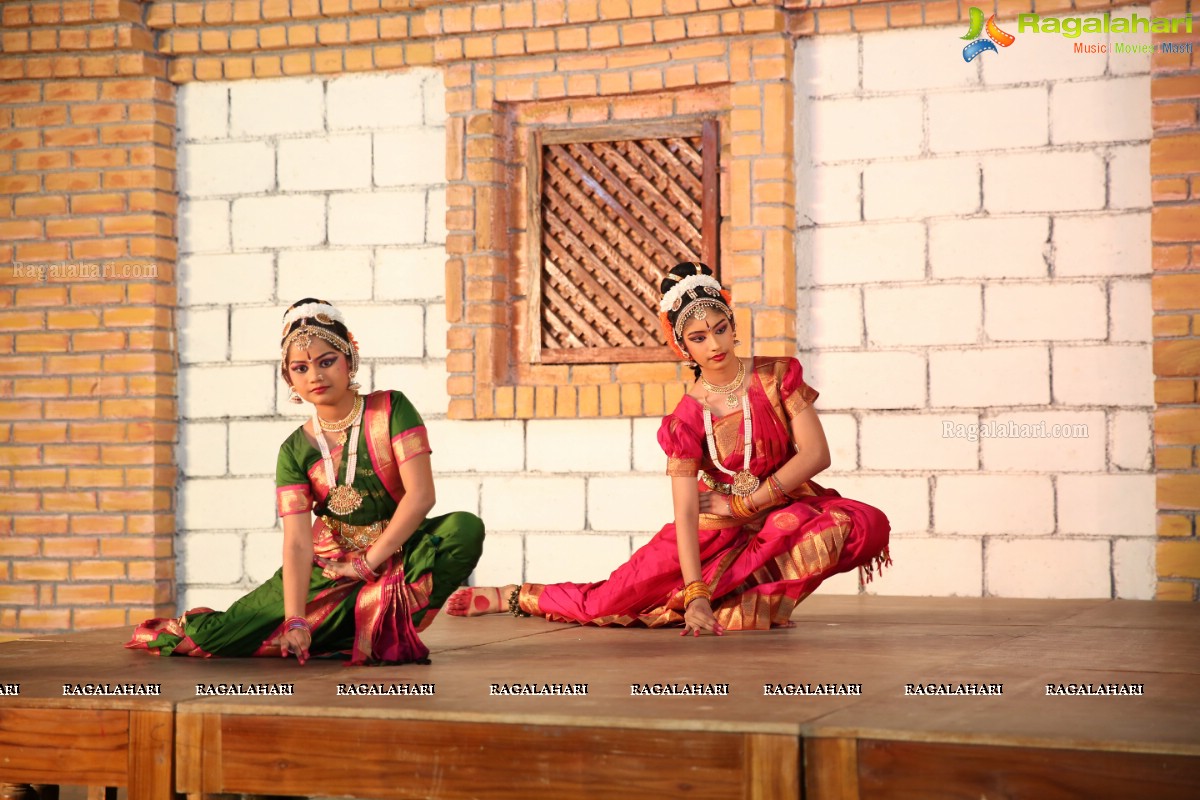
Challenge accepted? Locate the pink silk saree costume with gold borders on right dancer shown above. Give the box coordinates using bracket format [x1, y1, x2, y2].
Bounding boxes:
[518, 359, 890, 631]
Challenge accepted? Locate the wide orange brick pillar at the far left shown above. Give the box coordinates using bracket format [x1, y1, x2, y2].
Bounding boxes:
[0, 0, 176, 637]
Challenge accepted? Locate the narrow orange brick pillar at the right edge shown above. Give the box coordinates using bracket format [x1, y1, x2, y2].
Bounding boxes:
[1150, 0, 1200, 600]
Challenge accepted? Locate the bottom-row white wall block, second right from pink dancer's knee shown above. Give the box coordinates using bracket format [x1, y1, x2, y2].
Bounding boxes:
[985, 537, 1112, 599]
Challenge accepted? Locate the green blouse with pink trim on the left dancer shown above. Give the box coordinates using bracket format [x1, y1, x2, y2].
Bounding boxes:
[275, 391, 432, 525]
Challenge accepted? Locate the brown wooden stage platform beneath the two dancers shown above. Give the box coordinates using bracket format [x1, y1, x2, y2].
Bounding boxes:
[0, 596, 1200, 800]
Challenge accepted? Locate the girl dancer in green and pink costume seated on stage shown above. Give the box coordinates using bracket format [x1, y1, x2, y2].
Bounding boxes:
[125, 297, 484, 664]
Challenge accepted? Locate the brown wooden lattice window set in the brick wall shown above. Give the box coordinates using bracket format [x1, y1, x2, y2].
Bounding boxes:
[529, 120, 720, 363]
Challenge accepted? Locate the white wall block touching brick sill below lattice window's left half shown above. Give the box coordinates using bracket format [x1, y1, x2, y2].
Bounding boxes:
[526, 420, 632, 474]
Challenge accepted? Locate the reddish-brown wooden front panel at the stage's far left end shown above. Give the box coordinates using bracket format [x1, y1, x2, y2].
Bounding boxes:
[0, 708, 130, 786]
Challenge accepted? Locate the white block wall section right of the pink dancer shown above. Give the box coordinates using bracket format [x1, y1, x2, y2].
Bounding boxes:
[794, 8, 1154, 599]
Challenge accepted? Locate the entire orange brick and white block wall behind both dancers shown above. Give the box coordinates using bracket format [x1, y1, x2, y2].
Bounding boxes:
[0, 0, 1200, 636]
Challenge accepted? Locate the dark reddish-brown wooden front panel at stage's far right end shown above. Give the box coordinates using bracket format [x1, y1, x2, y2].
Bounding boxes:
[858, 740, 1200, 800]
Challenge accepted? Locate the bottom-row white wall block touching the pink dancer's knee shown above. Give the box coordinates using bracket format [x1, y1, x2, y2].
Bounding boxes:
[868, 537, 983, 597]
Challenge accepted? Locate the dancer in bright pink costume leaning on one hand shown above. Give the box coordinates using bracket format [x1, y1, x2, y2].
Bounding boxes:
[446, 261, 890, 636]
